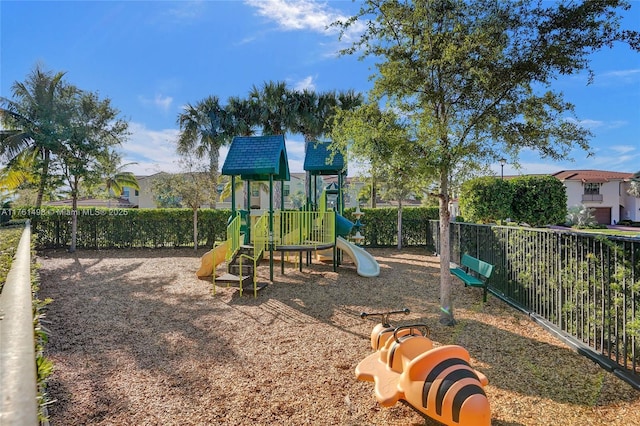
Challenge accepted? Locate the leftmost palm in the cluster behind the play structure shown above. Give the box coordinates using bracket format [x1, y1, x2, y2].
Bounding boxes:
[178, 96, 232, 208]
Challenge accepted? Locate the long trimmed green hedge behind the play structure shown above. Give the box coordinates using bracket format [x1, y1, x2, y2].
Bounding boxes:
[13, 207, 438, 249]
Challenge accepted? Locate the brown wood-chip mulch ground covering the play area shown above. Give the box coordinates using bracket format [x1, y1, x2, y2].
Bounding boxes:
[38, 249, 640, 426]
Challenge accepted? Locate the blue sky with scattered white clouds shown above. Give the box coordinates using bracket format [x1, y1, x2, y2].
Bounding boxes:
[0, 0, 640, 175]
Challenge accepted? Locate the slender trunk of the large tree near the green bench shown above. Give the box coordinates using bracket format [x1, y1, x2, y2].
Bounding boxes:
[439, 170, 456, 326]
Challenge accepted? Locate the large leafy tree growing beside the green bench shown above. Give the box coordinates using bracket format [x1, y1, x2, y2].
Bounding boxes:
[334, 0, 640, 325]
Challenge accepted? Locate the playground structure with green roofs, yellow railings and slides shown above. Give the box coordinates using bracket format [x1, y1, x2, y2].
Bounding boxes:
[196, 135, 380, 296]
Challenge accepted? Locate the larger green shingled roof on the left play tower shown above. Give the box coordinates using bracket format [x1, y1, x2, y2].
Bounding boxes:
[222, 135, 290, 180]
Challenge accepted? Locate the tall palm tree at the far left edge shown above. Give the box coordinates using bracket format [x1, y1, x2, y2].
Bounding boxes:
[0, 65, 78, 208]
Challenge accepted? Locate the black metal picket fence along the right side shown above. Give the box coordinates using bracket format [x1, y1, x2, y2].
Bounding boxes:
[427, 221, 640, 390]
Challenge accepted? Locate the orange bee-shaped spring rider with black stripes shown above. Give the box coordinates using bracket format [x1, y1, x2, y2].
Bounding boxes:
[356, 309, 491, 426]
